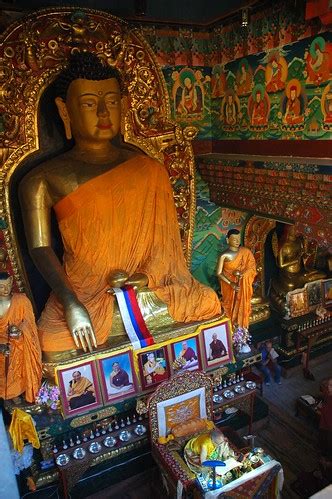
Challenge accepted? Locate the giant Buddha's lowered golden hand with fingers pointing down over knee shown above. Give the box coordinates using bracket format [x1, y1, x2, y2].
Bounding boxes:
[65, 300, 97, 352]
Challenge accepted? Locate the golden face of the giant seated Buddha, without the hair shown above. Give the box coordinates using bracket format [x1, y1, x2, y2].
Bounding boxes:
[61, 78, 121, 143]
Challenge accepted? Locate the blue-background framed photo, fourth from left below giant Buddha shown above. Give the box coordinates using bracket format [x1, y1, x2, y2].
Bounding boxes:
[171, 335, 202, 372]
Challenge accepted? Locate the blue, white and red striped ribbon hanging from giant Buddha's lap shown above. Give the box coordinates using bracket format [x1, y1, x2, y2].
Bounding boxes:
[113, 286, 154, 350]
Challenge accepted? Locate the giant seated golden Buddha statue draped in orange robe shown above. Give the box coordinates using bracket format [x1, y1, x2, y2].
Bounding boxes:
[20, 52, 220, 360]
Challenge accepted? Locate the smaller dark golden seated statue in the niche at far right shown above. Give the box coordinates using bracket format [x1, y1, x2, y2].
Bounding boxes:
[270, 225, 326, 311]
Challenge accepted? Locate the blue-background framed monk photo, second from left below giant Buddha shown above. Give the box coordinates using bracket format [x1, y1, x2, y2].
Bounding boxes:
[97, 350, 136, 404]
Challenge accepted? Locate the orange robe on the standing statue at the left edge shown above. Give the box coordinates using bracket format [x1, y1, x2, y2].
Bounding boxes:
[0, 293, 42, 402]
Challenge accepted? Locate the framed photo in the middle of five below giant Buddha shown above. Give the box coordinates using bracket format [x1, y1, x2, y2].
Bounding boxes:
[138, 346, 170, 390]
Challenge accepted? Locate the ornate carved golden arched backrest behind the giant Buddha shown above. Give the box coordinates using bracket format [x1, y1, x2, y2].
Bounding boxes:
[0, 7, 196, 291]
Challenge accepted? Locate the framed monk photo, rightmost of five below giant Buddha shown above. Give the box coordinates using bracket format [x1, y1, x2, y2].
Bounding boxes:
[202, 322, 233, 368]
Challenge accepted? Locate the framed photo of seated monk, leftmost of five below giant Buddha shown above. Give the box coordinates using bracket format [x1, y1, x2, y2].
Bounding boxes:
[55, 360, 103, 418]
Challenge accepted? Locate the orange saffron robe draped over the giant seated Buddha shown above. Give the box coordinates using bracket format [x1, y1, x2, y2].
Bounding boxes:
[39, 155, 220, 352]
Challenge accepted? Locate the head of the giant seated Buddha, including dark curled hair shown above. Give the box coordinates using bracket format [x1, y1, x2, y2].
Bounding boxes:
[55, 52, 121, 145]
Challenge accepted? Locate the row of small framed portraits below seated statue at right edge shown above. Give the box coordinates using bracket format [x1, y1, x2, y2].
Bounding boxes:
[287, 279, 332, 318]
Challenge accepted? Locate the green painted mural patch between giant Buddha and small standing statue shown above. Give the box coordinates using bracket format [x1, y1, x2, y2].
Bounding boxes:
[191, 172, 248, 291]
